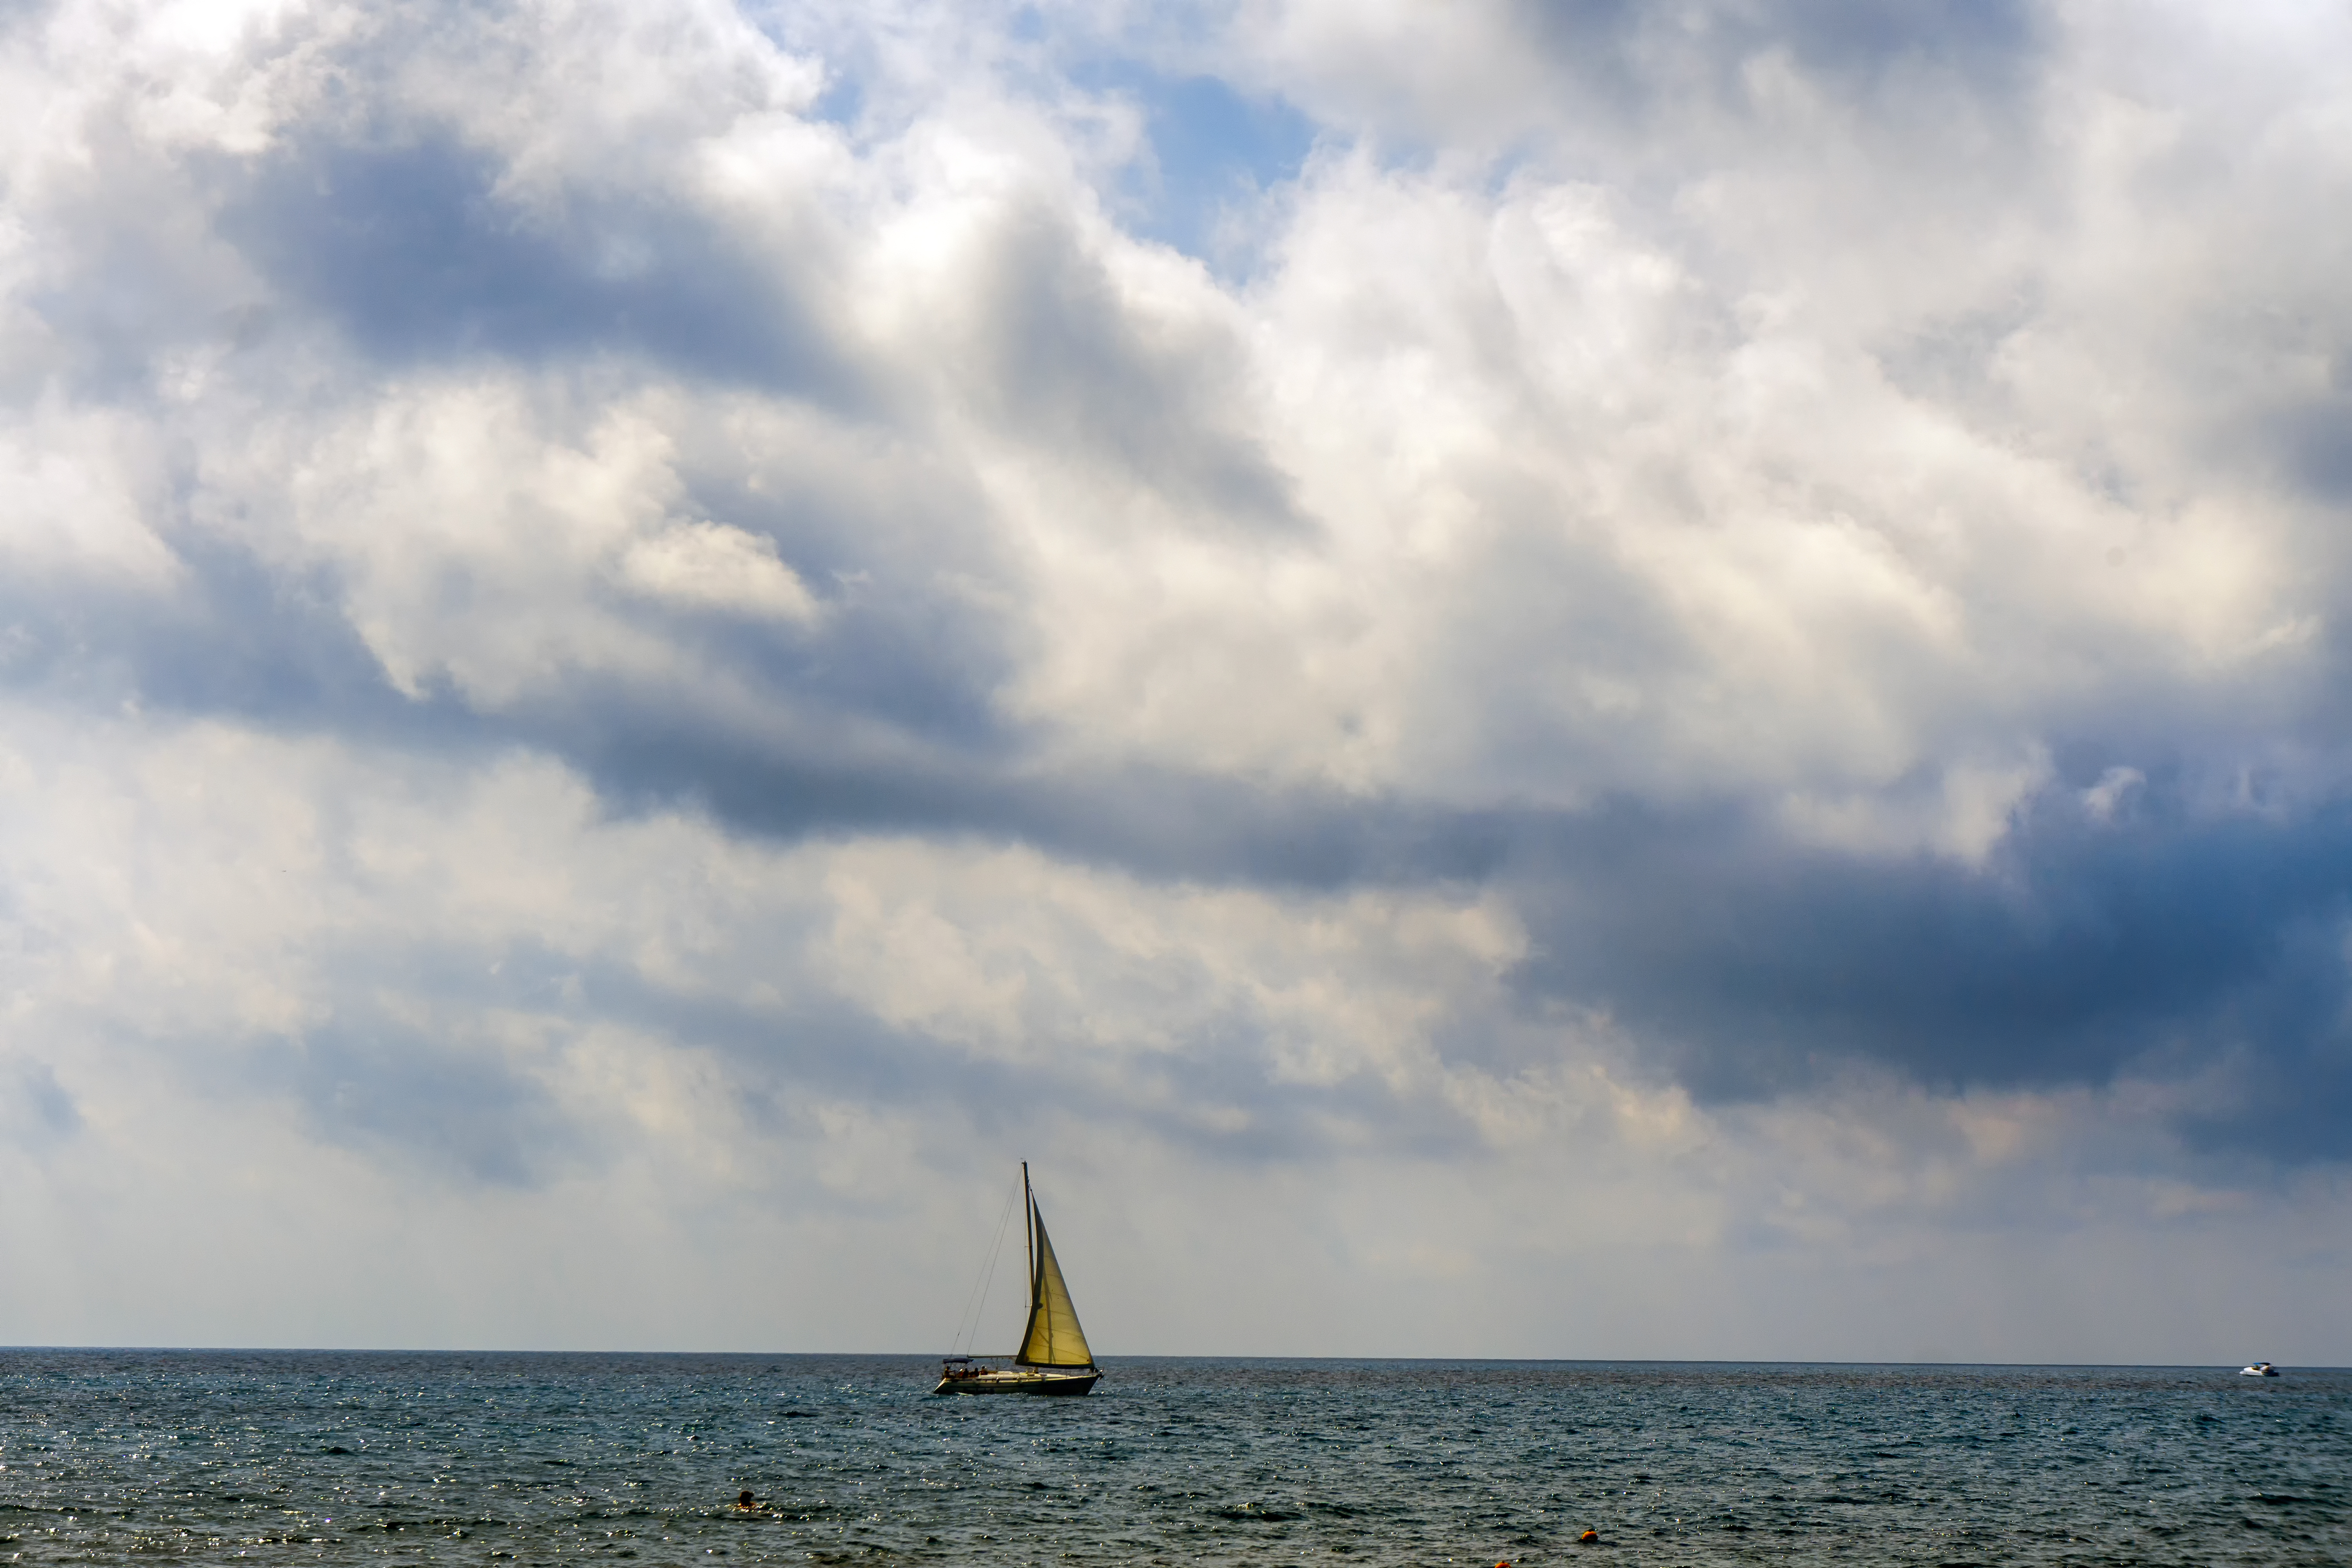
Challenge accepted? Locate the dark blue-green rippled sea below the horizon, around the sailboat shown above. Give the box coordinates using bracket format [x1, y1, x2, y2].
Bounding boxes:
[0, 1352, 2352, 1566]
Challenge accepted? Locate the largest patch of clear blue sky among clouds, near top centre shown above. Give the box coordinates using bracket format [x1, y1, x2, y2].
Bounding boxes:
[1070, 61, 1317, 275]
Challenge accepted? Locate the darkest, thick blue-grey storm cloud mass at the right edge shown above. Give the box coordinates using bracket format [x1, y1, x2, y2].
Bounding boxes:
[1519, 778, 2352, 1161]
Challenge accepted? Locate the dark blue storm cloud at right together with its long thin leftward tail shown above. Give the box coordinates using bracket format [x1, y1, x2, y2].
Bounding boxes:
[501, 639, 2352, 1164]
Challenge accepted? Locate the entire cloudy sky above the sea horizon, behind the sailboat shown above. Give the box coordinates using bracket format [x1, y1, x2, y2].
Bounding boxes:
[0, 0, 2352, 1363]
